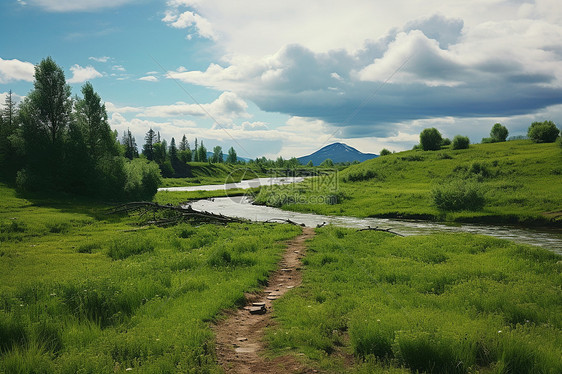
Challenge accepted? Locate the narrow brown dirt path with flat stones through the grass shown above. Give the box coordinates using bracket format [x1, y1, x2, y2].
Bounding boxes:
[214, 227, 316, 374]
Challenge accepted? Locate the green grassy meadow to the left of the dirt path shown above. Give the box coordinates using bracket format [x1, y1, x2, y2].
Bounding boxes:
[0, 185, 300, 373]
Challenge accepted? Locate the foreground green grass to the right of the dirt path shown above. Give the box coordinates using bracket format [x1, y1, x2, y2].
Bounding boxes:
[267, 227, 562, 373]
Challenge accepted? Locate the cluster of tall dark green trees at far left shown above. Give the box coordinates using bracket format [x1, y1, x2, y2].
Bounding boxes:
[0, 57, 160, 200]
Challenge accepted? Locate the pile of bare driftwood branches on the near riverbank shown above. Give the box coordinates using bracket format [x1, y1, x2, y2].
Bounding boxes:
[108, 201, 246, 226]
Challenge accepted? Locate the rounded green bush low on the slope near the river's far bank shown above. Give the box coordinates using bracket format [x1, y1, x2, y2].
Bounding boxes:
[431, 179, 486, 211]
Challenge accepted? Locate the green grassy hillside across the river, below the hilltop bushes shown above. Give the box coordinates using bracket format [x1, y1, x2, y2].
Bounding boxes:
[257, 140, 562, 225]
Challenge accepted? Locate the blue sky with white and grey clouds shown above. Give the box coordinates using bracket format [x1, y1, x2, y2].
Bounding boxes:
[0, 0, 562, 158]
